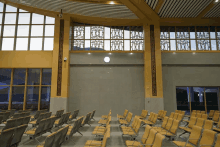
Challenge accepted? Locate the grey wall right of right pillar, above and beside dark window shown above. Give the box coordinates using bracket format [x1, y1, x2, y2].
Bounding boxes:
[162, 53, 220, 115]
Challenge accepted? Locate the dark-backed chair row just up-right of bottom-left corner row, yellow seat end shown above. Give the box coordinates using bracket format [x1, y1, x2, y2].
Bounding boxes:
[25, 117, 56, 139]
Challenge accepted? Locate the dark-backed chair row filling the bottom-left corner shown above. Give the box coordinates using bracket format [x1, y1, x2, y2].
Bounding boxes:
[0, 124, 28, 147]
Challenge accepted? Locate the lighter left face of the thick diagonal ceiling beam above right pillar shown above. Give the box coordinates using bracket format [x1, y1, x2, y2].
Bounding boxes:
[120, 0, 152, 24]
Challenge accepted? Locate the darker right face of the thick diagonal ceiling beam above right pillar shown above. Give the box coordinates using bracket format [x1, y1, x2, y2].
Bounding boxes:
[127, 0, 160, 23]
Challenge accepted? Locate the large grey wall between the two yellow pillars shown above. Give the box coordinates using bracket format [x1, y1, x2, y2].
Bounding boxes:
[68, 53, 145, 116]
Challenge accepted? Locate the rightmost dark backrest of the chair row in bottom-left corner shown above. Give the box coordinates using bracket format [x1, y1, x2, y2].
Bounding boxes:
[11, 124, 28, 146]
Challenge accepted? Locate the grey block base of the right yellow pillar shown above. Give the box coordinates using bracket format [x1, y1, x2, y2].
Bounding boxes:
[145, 98, 164, 113]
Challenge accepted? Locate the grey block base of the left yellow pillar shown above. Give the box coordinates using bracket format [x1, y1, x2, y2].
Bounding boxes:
[50, 97, 68, 114]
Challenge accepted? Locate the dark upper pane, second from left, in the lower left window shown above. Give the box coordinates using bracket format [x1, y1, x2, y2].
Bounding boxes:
[13, 69, 26, 85]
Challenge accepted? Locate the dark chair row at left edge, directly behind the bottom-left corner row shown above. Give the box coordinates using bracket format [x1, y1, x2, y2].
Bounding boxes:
[0, 116, 30, 132]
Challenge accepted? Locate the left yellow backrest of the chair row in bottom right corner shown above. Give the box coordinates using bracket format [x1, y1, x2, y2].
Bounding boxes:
[189, 126, 202, 146]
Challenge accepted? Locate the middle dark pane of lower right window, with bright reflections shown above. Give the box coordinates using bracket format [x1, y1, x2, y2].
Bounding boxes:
[190, 87, 205, 111]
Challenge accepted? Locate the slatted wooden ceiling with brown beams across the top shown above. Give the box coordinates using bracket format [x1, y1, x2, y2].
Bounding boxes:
[0, 0, 220, 25]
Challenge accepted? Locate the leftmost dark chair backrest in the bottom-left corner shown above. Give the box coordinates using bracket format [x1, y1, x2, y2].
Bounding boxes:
[0, 128, 15, 147]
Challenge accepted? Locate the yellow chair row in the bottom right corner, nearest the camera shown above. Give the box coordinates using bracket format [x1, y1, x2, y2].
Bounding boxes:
[172, 126, 220, 147]
